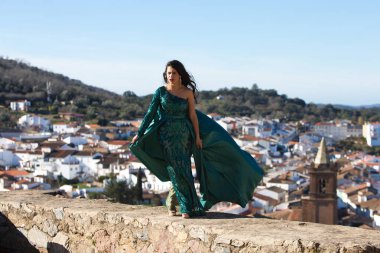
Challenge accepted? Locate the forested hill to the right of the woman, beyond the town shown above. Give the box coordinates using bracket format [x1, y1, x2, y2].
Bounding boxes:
[196, 84, 380, 123]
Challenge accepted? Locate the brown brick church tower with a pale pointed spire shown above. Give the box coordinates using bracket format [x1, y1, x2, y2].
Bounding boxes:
[302, 138, 338, 224]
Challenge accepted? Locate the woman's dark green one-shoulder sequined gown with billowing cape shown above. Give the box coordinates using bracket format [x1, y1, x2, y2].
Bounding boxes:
[130, 86, 263, 216]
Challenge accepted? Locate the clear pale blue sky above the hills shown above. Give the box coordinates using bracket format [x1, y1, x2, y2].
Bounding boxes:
[0, 0, 380, 105]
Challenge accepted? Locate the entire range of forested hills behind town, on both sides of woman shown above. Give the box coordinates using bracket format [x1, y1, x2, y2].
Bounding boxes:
[0, 58, 380, 124]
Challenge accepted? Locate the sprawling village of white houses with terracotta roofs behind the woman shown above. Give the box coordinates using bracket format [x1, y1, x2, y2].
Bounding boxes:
[0, 101, 380, 229]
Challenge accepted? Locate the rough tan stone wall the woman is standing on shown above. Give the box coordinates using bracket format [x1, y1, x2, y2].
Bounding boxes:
[0, 191, 380, 253]
